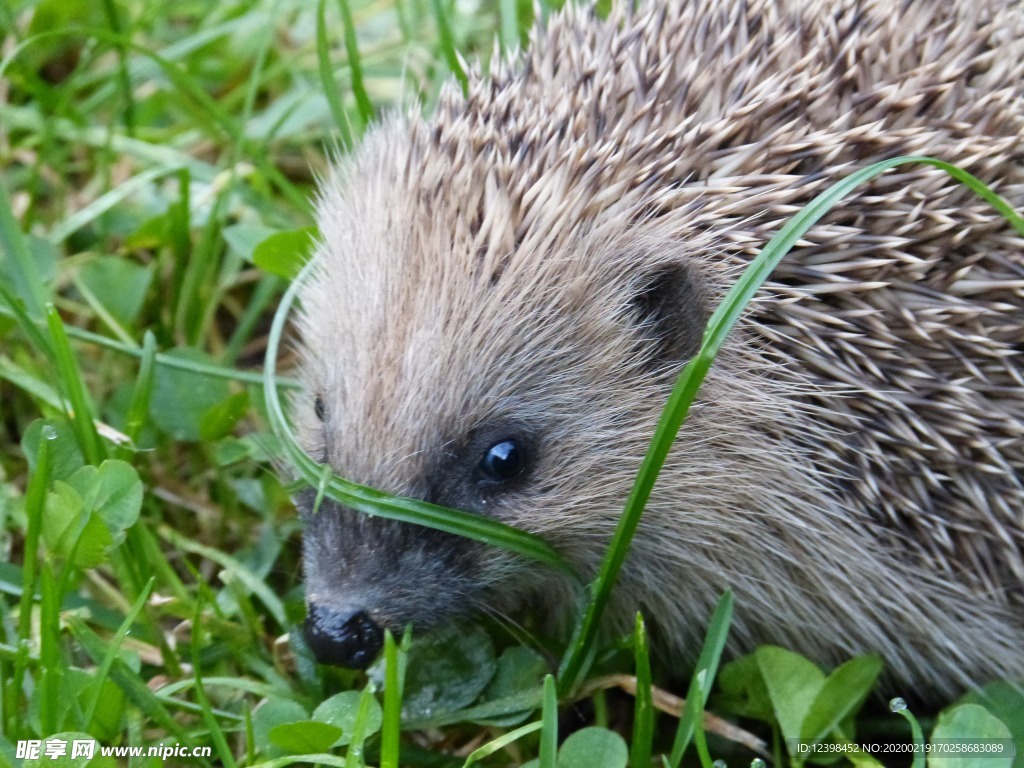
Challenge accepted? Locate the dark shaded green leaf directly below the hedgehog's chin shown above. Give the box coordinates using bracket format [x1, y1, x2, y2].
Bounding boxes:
[402, 625, 498, 720]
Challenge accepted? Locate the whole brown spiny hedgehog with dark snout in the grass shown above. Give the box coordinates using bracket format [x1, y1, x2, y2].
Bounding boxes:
[293, 0, 1024, 696]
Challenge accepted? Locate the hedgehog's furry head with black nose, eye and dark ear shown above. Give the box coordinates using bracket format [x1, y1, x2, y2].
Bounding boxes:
[295, 114, 708, 666]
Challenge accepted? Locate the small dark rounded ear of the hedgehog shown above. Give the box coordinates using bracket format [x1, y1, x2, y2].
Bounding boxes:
[631, 263, 708, 366]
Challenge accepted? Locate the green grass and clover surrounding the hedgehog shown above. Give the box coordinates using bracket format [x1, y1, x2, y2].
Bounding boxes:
[0, 0, 1024, 768]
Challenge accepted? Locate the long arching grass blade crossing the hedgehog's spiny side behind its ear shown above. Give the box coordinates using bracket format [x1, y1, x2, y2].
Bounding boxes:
[558, 156, 1024, 694]
